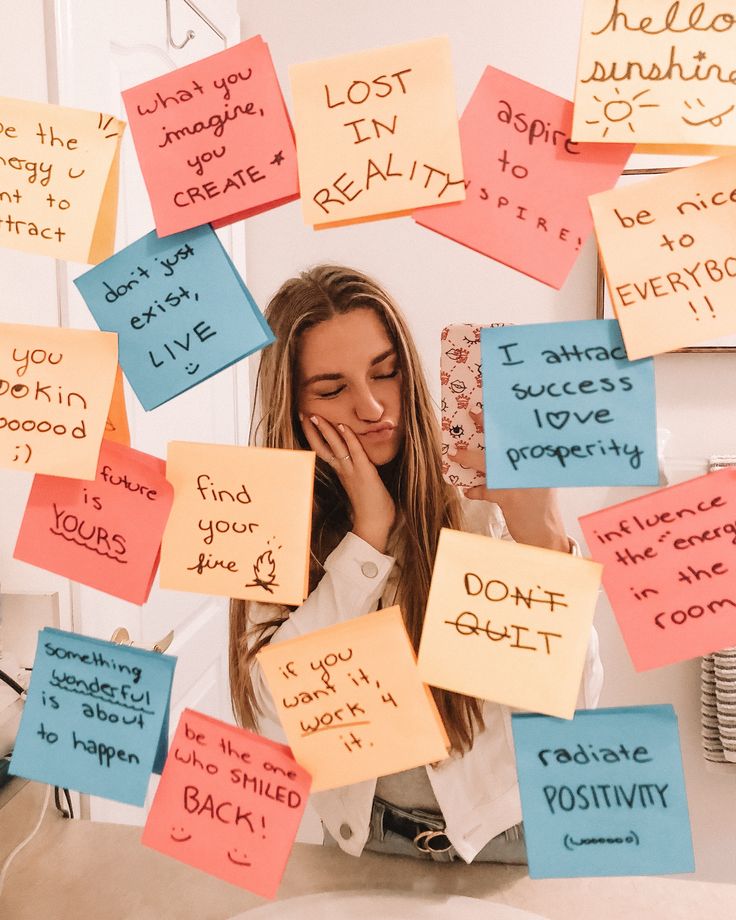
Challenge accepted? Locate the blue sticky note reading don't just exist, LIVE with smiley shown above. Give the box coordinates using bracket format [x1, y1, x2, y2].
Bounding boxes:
[74, 224, 274, 409]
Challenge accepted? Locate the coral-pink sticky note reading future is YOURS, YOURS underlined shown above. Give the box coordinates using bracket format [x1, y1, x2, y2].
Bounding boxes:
[13, 439, 174, 604]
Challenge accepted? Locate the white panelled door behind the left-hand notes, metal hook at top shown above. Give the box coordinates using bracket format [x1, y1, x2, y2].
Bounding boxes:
[49, 0, 248, 823]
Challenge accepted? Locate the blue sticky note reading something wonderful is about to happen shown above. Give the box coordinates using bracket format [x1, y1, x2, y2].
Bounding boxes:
[11, 629, 176, 805]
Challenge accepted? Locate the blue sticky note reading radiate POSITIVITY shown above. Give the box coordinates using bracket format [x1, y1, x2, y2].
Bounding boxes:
[511, 705, 695, 878]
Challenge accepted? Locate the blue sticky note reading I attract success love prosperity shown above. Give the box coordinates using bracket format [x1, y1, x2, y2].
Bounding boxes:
[481, 320, 659, 489]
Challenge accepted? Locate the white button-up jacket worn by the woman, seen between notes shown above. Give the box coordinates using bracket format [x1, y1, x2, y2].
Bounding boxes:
[251, 499, 603, 862]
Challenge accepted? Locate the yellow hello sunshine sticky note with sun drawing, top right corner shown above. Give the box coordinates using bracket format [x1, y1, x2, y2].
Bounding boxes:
[572, 0, 736, 147]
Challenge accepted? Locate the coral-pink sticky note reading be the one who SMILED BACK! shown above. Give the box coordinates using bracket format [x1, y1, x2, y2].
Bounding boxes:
[141, 709, 310, 898]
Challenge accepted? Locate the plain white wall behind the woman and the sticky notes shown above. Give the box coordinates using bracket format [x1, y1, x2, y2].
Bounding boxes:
[240, 0, 736, 882]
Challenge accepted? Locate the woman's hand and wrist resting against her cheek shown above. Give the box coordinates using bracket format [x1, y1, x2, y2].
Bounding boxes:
[299, 414, 396, 553]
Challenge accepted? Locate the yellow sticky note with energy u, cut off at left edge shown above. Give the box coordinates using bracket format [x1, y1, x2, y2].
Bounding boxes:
[0, 98, 125, 263]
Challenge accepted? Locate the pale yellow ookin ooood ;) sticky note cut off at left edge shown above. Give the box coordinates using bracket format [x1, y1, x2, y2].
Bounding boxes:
[0, 323, 118, 479]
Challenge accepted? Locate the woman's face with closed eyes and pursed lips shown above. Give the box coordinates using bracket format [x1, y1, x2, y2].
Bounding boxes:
[298, 308, 404, 466]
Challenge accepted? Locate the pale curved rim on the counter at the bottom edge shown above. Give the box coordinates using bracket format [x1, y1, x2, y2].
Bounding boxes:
[230, 890, 547, 920]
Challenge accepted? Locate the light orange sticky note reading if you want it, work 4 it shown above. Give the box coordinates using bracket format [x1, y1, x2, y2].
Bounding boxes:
[258, 607, 448, 792]
